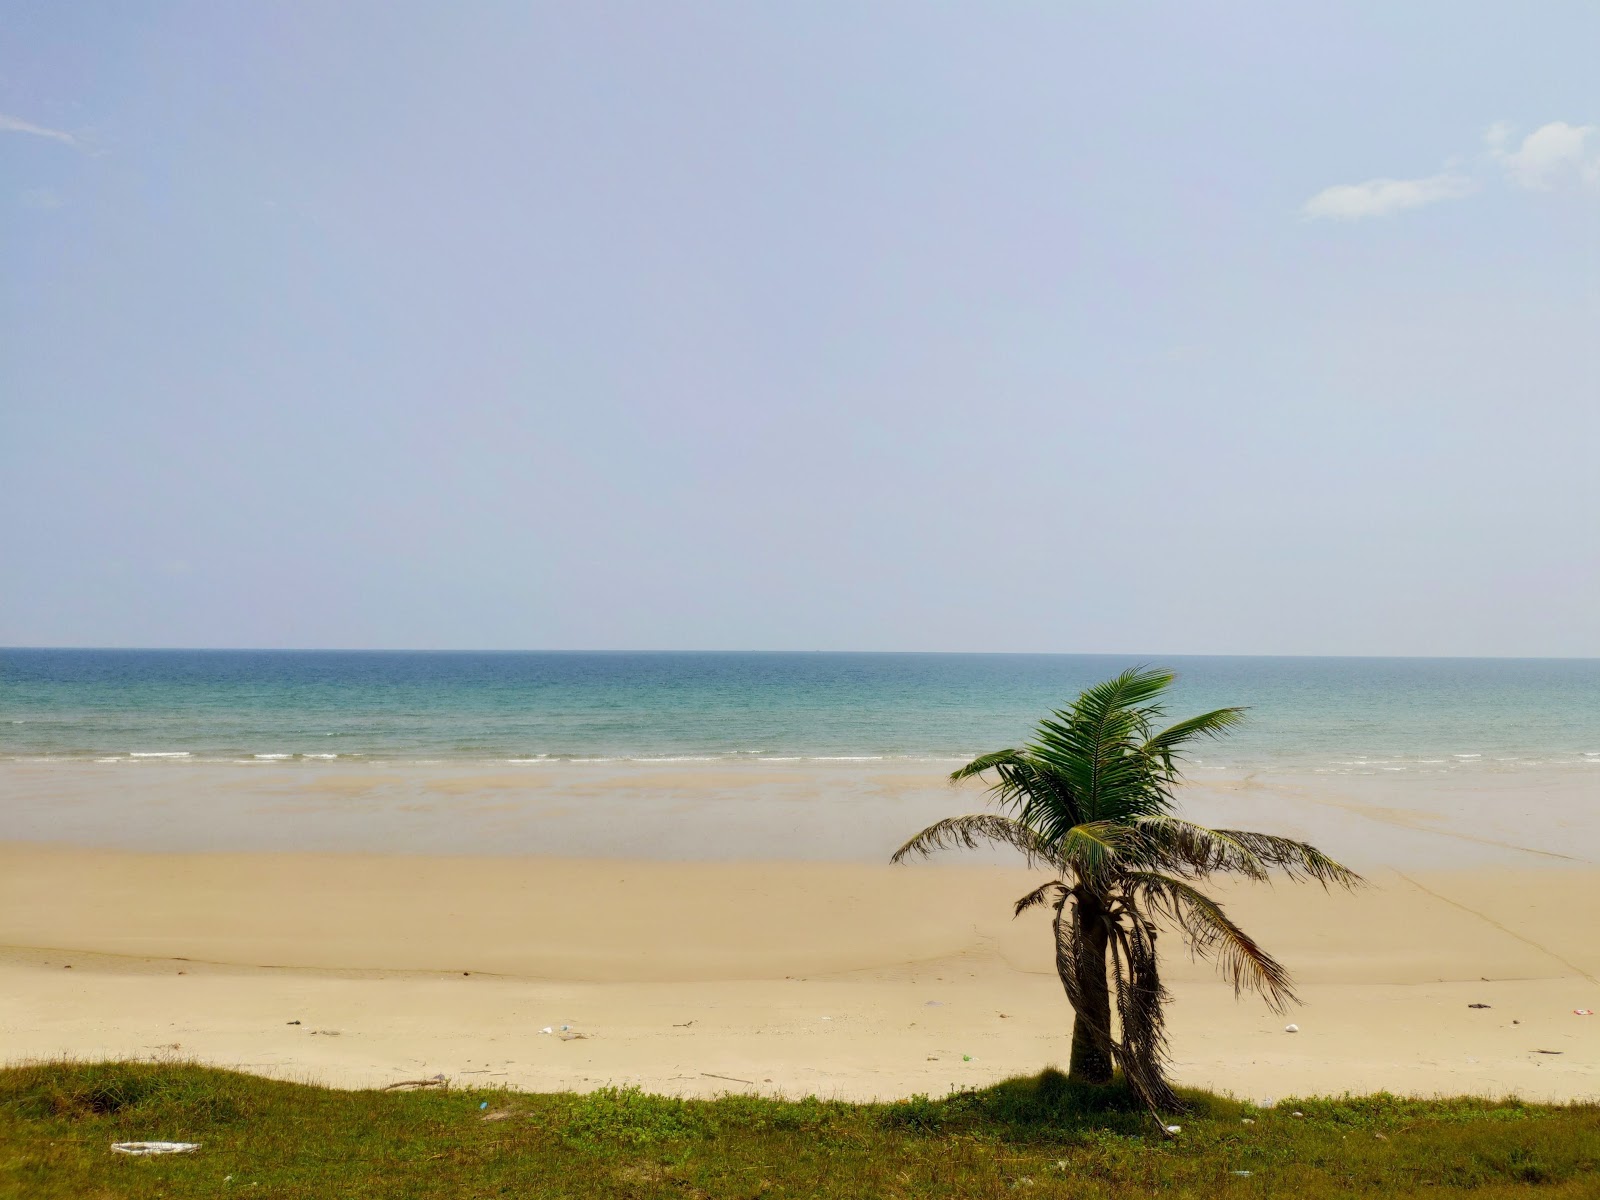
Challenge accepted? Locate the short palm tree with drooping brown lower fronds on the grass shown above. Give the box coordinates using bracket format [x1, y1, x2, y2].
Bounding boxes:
[893, 669, 1362, 1109]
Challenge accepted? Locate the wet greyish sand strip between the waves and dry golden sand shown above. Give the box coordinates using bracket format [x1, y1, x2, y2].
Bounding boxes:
[0, 760, 1600, 869]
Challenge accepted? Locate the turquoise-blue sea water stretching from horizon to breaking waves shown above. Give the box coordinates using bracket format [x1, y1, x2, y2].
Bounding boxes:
[0, 650, 1600, 781]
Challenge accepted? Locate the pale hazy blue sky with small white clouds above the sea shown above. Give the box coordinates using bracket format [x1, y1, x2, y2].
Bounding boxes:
[0, 0, 1600, 656]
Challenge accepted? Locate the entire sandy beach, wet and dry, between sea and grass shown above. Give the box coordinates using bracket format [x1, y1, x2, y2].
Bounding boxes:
[0, 763, 1600, 1099]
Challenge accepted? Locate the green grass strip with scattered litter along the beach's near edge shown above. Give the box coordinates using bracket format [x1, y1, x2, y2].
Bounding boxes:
[0, 1062, 1600, 1200]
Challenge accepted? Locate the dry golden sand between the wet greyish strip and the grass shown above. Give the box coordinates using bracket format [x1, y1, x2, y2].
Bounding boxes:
[0, 838, 1600, 1099]
